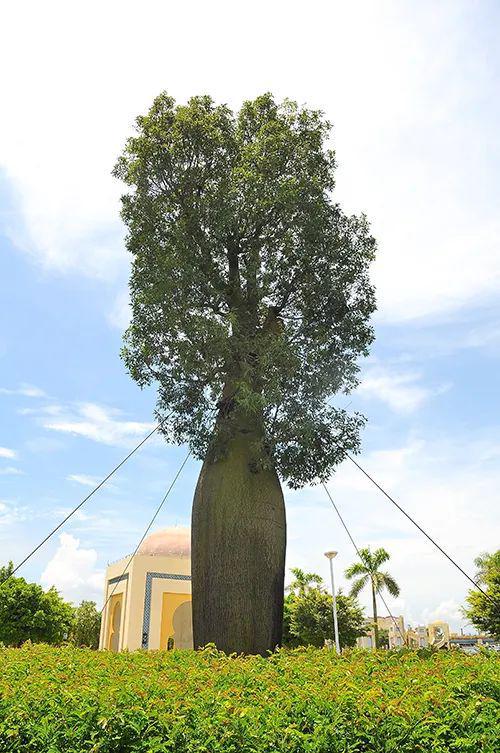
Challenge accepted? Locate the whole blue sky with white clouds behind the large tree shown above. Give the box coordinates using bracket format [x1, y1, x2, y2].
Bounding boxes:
[0, 2, 500, 627]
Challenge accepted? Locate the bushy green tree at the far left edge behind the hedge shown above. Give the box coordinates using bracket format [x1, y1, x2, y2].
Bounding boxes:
[0, 562, 73, 646]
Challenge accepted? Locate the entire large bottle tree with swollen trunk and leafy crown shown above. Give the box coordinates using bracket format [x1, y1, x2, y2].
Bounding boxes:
[115, 94, 375, 653]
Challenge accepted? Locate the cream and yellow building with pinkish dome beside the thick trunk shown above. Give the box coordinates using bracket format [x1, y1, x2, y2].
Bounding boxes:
[99, 527, 193, 651]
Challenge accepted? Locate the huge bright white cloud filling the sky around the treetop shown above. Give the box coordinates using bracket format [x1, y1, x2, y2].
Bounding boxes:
[0, 0, 500, 318]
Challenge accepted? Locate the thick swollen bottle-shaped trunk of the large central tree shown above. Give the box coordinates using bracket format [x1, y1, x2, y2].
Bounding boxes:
[191, 424, 286, 654]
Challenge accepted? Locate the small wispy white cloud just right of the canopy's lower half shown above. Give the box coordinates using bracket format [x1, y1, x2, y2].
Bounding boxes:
[356, 366, 449, 414]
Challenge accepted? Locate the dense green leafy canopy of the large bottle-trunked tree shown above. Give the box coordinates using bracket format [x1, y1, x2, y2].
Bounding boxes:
[115, 94, 375, 487]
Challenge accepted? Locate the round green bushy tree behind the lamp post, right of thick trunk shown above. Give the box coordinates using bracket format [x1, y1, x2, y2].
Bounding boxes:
[283, 568, 365, 647]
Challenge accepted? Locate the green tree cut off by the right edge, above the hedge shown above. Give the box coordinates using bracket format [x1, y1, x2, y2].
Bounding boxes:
[464, 549, 500, 640]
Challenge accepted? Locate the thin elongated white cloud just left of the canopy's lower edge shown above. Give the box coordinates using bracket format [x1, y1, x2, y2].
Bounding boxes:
[40, 403, 153, 447]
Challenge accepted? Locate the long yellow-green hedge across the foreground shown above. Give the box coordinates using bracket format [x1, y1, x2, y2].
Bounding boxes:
[0, 645, 500, 753]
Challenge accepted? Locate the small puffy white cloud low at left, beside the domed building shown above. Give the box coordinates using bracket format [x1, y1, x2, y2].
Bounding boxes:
[40, 533, 104, 603]
